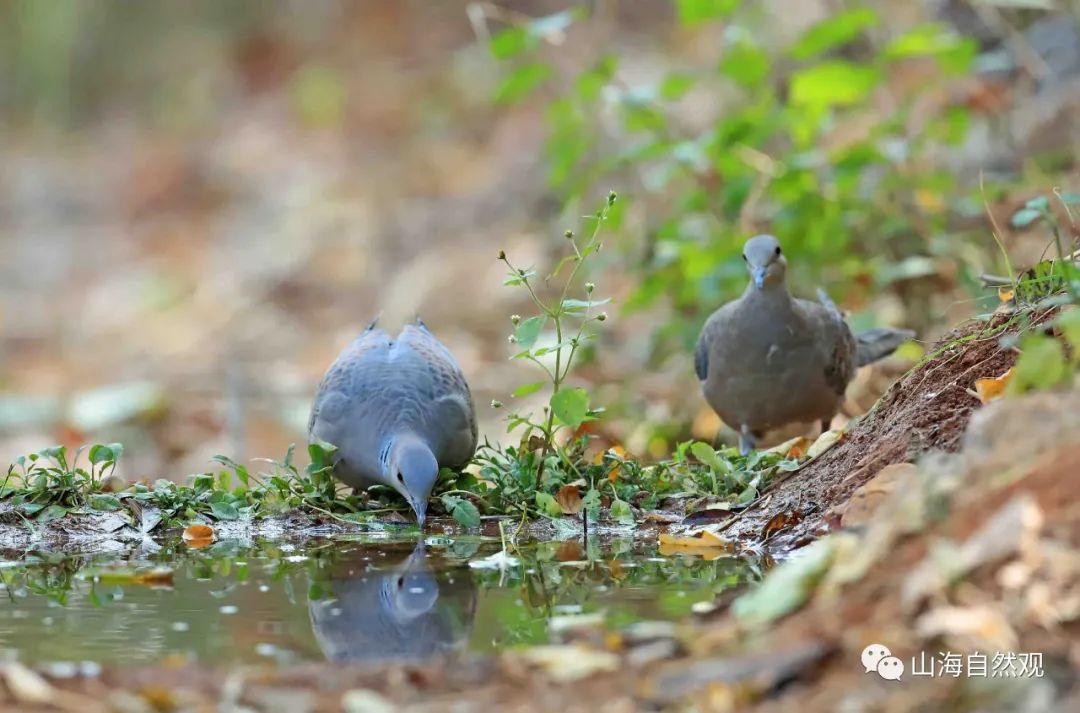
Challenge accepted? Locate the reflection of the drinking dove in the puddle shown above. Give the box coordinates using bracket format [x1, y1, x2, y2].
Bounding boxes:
[308, 541, 476, 663]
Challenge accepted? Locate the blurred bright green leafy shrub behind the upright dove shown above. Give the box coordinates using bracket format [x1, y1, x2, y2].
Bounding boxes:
[494, 0, 985, 359]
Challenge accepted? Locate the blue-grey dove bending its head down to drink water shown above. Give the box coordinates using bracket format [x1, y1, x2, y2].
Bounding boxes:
[308, 319, 476, 527]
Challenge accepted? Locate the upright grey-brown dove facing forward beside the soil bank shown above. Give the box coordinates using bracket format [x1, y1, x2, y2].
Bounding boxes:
[693, 236, 915, 455]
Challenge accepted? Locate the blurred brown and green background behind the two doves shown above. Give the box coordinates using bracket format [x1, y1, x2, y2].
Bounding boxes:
[0, 0, 1080, 477]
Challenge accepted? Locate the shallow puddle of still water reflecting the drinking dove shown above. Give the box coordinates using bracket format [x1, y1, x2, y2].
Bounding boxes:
[0, 537, 759, 674]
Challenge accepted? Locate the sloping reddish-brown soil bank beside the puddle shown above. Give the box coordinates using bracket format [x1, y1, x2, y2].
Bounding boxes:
[726, 311, 1053, 549]
